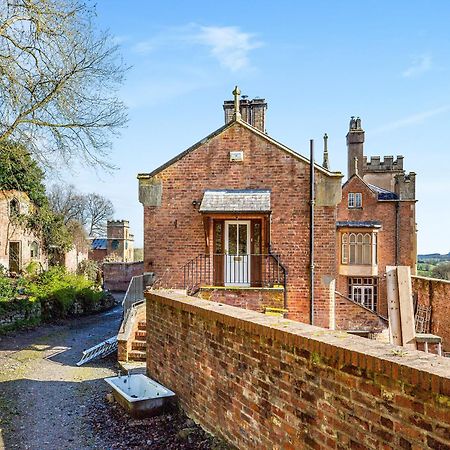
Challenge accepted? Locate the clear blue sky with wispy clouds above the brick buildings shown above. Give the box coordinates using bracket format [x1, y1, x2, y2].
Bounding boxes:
[62, 0, 450, 253]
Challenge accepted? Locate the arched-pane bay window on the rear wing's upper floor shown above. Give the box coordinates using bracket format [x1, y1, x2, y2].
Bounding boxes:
[341, 233, 377, 265]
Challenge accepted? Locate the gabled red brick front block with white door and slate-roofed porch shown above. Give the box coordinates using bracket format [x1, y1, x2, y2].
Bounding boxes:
[138, 88, 342, 327]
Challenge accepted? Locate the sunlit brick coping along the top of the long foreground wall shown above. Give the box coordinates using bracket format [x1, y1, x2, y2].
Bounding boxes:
[145, 290, 450, 397]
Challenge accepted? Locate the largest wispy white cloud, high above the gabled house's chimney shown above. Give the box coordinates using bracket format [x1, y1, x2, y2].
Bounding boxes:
[132, 24, 262, 72]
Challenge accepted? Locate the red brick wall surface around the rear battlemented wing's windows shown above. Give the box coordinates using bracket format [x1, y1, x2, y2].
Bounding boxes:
[336, 177, 416, 316]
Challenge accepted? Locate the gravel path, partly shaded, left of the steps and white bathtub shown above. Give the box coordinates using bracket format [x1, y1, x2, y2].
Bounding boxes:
[0, 296, 224, 450]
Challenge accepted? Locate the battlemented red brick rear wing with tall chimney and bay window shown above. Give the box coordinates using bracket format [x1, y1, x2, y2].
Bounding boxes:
[336, 118, 417, 322]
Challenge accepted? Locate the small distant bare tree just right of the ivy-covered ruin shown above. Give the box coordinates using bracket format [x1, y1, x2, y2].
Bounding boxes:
[47, 184, 86, 225]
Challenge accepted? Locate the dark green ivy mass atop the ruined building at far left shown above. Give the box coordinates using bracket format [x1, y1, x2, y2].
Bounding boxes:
[0, 142, 48, 207]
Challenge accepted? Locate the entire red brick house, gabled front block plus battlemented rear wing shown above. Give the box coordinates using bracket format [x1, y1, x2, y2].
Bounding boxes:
[138, 90, 415, 332]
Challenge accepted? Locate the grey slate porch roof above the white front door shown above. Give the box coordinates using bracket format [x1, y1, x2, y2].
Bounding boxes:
[200, 189, 270, 213]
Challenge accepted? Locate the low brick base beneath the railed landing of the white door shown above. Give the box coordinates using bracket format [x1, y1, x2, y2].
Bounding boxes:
[197, 287, 284, 312]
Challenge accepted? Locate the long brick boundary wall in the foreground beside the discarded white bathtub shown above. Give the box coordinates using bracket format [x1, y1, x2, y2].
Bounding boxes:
[146, 291, 450, 450]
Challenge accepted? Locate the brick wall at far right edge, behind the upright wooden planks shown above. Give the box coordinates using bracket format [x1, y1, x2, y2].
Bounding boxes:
[411, 276, 450, 352]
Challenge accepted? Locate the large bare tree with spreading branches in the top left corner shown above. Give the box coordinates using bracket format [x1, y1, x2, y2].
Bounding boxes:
[0, 0, 126, 167]
